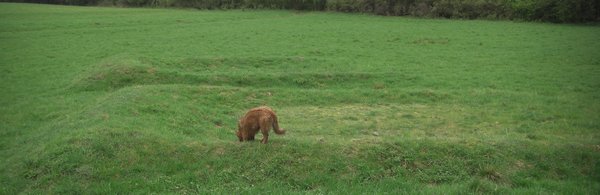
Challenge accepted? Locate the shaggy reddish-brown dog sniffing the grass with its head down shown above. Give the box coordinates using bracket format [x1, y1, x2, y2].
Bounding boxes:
[236, 106, 285, 144]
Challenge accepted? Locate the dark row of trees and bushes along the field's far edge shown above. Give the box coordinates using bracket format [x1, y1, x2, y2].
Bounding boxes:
[0, 0, 600, 23]
